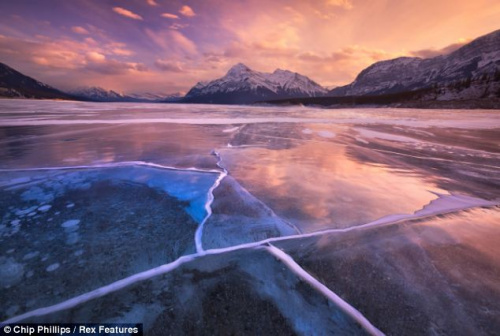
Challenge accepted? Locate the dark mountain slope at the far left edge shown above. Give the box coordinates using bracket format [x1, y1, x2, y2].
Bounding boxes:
[0, 63, 74, 99]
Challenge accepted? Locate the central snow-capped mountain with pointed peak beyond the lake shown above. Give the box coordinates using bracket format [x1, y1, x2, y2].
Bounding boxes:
[182, 63, 327, 104]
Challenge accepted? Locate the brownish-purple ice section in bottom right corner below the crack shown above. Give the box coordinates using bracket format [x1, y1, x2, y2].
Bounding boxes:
[275, 207, 500, 335]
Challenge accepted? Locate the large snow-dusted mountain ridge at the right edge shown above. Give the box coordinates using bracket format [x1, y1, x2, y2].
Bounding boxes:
[329, 30, 500, 96]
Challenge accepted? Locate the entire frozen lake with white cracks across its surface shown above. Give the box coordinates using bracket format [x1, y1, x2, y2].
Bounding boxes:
[0, 100, 500, 335]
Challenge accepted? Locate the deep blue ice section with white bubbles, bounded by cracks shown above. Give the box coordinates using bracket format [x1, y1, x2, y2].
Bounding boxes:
[0, 165, 219, 318]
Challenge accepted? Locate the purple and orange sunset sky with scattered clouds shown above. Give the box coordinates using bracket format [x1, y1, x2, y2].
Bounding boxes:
[0, 0, 500, 94]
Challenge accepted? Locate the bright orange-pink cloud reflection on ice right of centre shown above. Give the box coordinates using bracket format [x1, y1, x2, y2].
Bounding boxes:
[221, 142, 444, 232]
